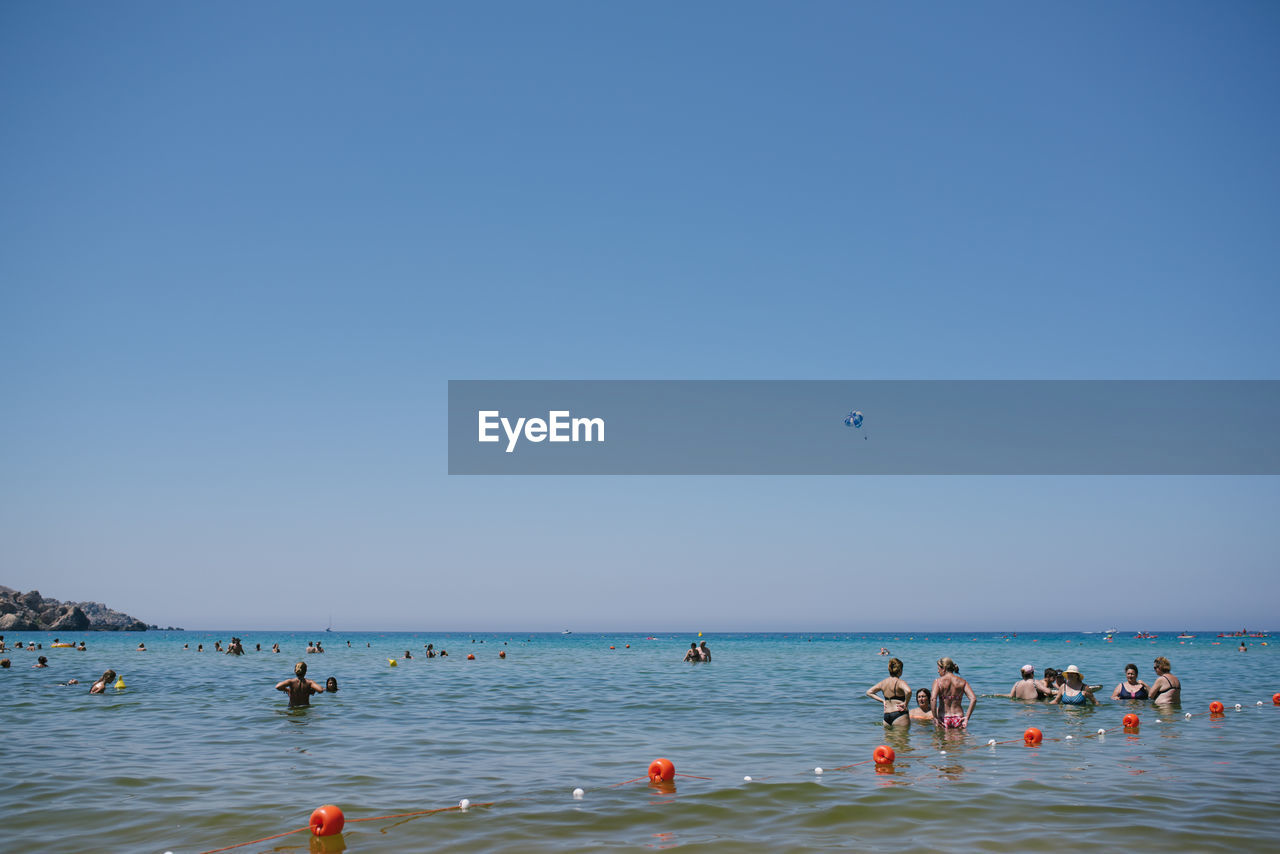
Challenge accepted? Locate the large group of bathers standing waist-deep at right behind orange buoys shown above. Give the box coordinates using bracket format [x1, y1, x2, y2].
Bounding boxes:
[867, 656, 1183, 730]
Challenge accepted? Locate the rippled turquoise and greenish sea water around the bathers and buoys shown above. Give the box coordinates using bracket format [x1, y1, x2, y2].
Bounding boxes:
[0, 631, 1280, 853]
